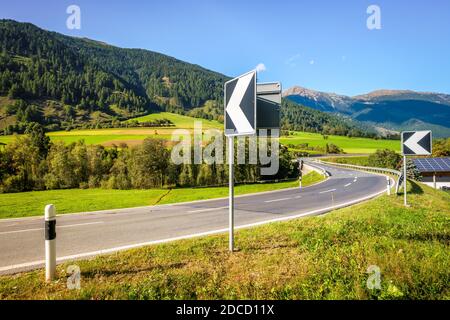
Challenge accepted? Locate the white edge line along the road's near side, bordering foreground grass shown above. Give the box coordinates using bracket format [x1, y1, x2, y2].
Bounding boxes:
[0, 181, 386, 272]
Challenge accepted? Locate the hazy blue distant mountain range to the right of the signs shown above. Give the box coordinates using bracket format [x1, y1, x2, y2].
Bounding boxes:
[283, 87, 450, 137]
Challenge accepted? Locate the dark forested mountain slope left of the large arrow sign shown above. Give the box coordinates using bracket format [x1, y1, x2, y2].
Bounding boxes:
[0, 20, 228, 129]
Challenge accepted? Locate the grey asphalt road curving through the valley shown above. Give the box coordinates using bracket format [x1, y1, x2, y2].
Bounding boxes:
[0, 165, 386, 274]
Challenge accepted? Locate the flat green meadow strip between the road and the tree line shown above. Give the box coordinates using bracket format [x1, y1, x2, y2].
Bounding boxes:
[0, 172, 323, 218]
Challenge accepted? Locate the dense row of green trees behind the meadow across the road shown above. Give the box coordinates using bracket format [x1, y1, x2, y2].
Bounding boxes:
[0, 123, 298, 192]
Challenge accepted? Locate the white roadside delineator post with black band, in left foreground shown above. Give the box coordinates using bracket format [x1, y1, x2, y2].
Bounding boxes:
[44, 204, 56, 281]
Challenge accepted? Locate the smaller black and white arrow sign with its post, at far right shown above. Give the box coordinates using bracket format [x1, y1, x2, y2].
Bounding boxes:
[399, 131, 433, 207]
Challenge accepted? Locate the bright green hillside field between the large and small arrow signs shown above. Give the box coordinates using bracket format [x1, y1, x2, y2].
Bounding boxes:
[280, 132, 400, 153]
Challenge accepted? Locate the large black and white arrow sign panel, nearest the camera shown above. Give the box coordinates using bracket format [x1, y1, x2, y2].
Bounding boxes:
[225, 71, 256, 136]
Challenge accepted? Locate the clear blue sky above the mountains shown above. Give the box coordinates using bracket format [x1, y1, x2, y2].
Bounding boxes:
[0, 0, 450, 95]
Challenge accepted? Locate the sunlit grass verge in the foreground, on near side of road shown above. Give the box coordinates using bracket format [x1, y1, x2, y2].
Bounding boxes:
[0, 180, 450, 299]
